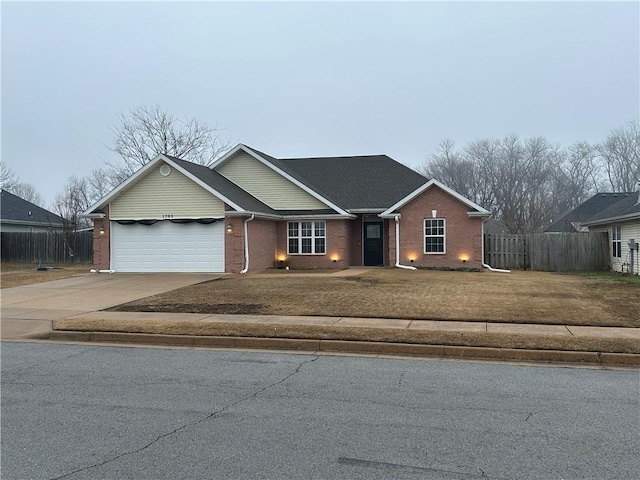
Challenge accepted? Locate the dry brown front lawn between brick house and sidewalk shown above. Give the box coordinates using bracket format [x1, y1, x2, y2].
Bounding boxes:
[111, 269, 640, 327]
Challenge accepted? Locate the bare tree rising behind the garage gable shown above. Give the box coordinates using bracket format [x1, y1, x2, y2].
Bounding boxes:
[107, 105, 229, 183]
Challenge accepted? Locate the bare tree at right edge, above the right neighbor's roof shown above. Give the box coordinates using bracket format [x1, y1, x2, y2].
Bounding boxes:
[596, 120, 640, 192]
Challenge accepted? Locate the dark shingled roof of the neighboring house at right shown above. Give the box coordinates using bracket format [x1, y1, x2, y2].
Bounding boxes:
[544, 192, 640, 233]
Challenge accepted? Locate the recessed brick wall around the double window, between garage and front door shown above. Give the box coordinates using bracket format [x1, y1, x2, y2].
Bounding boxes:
[276, 220, 357, 268]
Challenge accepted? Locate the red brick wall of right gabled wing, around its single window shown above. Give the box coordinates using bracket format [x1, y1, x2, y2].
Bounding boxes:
[387, 186, 482, 268]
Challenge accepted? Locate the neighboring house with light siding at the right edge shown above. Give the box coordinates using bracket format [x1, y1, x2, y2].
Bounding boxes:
[545, 190, 640, 275]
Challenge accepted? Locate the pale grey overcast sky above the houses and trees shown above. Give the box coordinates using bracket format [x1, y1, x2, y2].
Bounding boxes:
[1, 1, 640, 206]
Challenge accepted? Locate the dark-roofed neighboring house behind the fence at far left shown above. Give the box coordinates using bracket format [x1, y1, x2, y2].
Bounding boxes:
[0, 190, 64, 232]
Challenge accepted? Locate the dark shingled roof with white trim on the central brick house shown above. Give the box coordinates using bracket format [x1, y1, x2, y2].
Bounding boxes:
[83, 144, 490, 218]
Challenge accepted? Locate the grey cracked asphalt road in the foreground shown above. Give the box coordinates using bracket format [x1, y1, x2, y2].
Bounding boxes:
[1, 343, 640, 480]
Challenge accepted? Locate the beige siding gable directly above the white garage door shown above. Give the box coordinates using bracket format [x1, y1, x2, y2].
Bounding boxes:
[110, 162, 224, 220]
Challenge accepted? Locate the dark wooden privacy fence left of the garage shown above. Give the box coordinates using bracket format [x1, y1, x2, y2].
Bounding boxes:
[0, 232, 93, 264]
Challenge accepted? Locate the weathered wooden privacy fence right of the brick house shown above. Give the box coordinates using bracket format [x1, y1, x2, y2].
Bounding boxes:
[484, 232, 609, 272]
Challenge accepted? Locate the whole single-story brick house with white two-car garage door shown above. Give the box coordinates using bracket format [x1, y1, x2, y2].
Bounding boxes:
[85, 144, 489, 273]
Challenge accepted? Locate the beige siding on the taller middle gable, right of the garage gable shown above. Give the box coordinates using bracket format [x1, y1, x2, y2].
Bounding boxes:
[216, 152, 327, 210]
